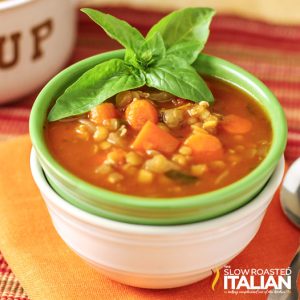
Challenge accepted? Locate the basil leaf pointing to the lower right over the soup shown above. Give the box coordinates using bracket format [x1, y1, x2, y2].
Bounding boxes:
[145, 56, 214, 103]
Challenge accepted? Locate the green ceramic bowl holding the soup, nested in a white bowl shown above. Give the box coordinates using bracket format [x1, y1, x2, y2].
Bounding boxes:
[30, 50, 287, 225]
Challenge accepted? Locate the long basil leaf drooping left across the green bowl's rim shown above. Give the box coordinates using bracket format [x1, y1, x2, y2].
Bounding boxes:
[48, 59, 145, 121]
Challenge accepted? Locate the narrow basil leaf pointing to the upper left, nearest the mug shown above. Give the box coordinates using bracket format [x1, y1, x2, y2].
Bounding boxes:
[81, 8, 145, 52]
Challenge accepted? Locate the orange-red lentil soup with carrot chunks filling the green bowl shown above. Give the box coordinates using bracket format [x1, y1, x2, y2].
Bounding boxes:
[45, 78, 272, 198]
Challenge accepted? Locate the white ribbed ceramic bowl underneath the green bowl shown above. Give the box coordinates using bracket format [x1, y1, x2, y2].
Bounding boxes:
[31, 152, 284, 289]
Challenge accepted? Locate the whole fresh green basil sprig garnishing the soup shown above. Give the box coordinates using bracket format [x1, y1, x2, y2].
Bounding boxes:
[48, 8, 214, 121]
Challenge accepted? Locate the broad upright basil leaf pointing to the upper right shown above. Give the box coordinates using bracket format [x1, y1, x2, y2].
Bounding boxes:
[147, 7, 215, 64]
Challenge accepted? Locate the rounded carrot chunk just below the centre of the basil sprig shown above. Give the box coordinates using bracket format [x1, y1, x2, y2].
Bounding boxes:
[125, 100, 158, 130]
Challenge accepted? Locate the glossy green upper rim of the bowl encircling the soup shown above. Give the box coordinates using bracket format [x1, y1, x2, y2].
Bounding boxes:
[29, 49, 287, 209]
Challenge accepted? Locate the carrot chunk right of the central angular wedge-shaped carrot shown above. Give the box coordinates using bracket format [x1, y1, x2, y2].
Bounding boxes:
[184, 133, 224, 163]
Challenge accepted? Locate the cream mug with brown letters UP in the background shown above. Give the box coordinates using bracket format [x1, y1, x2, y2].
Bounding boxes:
[0, 0, 77, 104]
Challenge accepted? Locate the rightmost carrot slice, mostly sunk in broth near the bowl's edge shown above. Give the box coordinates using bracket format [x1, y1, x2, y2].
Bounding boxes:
[221, 115, 252, 134]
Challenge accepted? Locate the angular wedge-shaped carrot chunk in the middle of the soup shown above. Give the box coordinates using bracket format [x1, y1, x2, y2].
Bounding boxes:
[131, 121, 180, 154]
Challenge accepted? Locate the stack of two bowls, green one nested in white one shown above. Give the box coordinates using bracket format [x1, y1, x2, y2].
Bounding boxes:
[30, 50, 287, 288]
